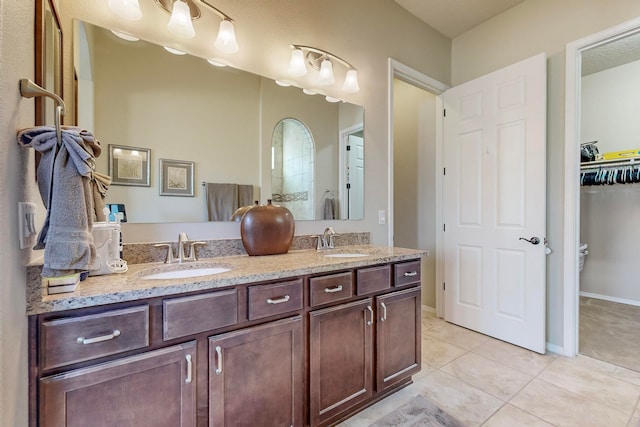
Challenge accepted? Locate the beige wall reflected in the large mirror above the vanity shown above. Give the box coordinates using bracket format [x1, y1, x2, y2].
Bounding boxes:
[73, 21, 364, 223]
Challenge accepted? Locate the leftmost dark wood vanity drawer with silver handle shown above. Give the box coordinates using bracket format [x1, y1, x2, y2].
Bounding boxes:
[40, 305, 149, 370]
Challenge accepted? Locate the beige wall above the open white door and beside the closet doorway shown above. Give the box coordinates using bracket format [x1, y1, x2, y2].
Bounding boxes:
[451, 0, 640, 346]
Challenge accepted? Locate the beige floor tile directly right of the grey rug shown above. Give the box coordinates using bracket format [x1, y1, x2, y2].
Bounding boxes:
[415, 371, 503, 427]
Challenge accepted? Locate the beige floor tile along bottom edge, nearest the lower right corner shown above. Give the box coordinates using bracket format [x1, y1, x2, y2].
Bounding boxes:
[510, 379, 629, 427]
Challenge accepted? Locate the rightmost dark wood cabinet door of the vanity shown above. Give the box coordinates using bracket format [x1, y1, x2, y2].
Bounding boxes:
[376, 288, 421, 391]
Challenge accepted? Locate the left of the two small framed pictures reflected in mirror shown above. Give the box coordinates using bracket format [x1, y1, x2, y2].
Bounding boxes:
[109, 144, 151, 187]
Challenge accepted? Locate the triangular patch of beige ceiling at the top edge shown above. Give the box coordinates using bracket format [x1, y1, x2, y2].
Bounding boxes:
[395, 0, 524, 38]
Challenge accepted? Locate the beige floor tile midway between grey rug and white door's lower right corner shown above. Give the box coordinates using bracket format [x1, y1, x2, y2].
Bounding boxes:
[440, 353, 533, 402]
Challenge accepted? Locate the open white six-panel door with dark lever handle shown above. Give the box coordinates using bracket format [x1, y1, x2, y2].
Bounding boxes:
[443, 54, 547, 353]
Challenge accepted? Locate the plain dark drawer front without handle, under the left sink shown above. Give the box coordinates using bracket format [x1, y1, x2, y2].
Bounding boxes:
[162, 289, 238, 341]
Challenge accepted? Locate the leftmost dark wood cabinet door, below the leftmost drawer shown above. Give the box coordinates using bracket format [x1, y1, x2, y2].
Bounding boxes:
[39, 341, 196, 427]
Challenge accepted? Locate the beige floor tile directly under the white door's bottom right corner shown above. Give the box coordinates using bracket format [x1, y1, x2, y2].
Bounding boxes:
[472, 338, 557, 375]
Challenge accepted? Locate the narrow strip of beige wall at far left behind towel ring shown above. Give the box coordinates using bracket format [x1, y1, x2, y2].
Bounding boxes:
[0, 1, 39, 427]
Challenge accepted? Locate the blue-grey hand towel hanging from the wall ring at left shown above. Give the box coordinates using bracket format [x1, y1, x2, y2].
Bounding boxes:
[18, 126, 101, 277]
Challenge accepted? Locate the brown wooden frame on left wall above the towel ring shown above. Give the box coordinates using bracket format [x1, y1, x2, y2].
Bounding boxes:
[34, 0, 64, 126]
